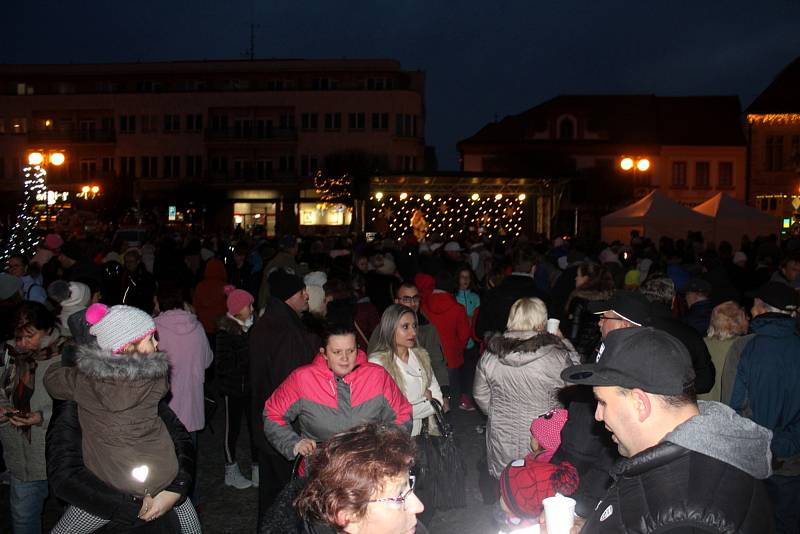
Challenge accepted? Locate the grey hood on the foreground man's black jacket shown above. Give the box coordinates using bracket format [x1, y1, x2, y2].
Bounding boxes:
[662, 401, 772, 479]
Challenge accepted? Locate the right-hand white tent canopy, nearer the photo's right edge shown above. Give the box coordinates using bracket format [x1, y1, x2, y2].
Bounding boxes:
[694, 193, 780, 246]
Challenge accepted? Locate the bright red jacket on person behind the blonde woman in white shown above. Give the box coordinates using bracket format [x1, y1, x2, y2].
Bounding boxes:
[422, 291, 471, 369]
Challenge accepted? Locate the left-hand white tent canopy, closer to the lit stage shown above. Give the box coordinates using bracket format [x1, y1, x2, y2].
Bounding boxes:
[600, 189, 714, 243]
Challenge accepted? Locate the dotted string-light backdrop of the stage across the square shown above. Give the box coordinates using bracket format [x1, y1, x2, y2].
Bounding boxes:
[370, 193, 525, 239]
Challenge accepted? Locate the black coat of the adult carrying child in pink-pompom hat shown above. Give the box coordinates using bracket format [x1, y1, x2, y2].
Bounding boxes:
[45, 401, 195, 534]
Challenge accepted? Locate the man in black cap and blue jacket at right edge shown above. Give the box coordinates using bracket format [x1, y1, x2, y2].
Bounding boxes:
[725, 282, 800, 533]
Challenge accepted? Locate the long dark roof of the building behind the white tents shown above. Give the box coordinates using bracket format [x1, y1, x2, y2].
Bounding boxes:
[459, 95, 746, 148]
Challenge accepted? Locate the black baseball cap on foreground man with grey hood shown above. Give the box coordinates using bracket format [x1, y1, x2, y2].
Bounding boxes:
[561, 327, 695, 395]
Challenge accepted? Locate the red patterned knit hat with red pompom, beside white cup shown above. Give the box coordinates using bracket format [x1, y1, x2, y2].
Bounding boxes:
[500, 454, 578, 518]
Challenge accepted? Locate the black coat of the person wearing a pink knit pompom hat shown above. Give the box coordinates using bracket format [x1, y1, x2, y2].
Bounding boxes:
[214, 314, 250, 398]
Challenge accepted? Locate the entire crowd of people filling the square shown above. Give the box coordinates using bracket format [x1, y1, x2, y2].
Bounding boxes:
[0, 227, 800, 533]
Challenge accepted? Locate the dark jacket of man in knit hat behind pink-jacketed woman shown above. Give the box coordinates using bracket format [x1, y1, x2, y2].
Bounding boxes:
[250, 297, 320, 454]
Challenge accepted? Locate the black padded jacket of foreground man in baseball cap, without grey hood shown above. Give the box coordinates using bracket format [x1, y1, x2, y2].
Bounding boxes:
[581, 442, 775, 534]
